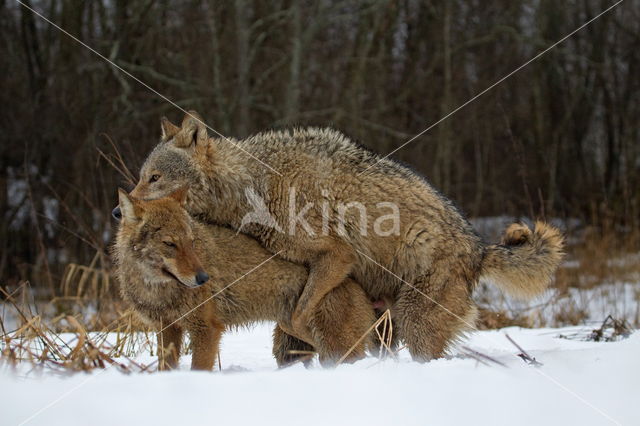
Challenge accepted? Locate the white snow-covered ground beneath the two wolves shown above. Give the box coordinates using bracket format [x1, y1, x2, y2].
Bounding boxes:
[0, 324, 640, 426]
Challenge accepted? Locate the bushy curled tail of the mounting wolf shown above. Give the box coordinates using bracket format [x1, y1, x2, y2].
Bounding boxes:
[480, 222, 564, 299]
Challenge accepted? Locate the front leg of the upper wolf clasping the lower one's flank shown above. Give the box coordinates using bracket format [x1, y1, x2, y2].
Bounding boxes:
[291, 238, 356, 342]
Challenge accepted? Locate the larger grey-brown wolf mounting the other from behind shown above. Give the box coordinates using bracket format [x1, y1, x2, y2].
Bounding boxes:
[122, 112, 563, 361]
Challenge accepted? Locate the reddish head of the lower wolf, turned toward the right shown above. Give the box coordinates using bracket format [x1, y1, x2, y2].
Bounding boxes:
[117, 189, 209, 287]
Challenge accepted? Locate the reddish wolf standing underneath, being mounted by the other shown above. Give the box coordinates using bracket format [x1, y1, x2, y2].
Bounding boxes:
[113, 190, 375, 370]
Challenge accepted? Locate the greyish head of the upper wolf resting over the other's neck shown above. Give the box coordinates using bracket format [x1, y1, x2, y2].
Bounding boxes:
[131, 111, 209, 199]
